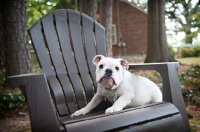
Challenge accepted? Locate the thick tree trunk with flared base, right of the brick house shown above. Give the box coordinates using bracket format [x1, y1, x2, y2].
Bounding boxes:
[145, 0, 175, 63]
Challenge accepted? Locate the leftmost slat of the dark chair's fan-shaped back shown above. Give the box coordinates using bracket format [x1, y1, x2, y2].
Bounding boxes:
[29, 22, 69, 115]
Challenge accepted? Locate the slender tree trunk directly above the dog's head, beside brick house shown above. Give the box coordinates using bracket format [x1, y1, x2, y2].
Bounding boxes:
[100, 0, 113, 57]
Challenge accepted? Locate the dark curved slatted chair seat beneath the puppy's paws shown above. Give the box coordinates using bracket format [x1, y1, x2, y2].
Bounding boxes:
[63, 102, 186, 132]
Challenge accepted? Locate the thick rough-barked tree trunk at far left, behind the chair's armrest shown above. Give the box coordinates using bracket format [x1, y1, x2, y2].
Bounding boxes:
[0, 0, 31, 76]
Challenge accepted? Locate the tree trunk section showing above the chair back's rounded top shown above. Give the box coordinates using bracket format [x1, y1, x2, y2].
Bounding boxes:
[80, 0, 97, 20]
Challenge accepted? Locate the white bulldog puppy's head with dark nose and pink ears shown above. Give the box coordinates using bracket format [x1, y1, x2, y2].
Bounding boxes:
[93, 55, 128, 90]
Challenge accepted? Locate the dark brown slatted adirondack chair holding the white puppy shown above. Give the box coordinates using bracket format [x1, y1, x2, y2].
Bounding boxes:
[8, 9, 190, 132]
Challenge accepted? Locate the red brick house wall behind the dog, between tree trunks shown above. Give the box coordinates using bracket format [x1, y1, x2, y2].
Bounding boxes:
[113, 0, 147, 56]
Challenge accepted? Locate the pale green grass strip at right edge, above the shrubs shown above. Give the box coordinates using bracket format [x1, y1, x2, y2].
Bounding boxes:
[175, 57, 200, 65]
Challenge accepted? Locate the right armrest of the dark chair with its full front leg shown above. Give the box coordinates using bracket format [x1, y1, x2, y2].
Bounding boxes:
[129, 62, 190, 131]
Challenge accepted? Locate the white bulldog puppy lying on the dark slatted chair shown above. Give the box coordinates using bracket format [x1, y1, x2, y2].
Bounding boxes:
[71, 55, 162, 118]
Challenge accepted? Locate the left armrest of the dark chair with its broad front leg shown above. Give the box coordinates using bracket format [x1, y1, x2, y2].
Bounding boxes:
[8, 73, 60, 132]
